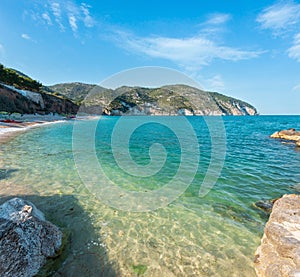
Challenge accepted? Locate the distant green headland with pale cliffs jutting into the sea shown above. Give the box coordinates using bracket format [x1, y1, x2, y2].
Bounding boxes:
[48, 83, 258, 115]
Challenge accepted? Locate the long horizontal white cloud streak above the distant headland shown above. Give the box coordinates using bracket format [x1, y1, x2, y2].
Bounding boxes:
[115, 31, 262, 70]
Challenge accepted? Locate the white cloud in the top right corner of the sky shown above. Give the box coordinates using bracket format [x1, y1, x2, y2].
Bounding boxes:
[256, 1, 300, 35]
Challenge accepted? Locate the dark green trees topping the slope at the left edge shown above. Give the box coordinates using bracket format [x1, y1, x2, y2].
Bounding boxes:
[0, 64, 42, 92]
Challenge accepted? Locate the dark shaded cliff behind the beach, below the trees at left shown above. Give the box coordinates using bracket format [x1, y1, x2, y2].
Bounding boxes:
[0, 84, 78, 114]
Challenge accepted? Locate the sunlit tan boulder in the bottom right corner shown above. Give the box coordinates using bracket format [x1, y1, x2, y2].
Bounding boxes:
[255, 194, 300, 277]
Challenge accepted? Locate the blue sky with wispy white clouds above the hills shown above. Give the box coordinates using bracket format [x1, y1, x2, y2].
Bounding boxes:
[0, 0, 300, 114]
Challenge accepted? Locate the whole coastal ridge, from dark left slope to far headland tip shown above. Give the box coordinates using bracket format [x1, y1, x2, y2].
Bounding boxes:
[0, 64, 257, 115]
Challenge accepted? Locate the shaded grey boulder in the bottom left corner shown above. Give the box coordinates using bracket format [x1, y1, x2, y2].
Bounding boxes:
[0, 198, 62, 277]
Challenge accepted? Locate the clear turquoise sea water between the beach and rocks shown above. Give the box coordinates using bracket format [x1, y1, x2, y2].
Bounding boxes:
[0, 116, 300, 276]
